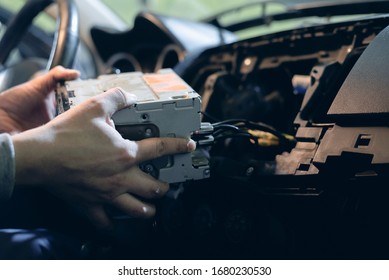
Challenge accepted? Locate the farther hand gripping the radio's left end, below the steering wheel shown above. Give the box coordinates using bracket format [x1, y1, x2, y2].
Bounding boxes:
[0, 66, 79, 134]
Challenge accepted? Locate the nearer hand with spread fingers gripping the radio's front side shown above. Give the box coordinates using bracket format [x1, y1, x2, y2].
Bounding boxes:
[12, 88, 195, 228]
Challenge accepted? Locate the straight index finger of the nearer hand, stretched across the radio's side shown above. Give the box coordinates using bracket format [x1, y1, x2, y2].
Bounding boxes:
[130, 137, 196, 163]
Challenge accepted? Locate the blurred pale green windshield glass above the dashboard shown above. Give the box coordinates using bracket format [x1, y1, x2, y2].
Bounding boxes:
[98, 0, 380, 39]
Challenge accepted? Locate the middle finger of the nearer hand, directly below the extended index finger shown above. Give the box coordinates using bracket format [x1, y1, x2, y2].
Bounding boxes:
[116, 167, 169, 199]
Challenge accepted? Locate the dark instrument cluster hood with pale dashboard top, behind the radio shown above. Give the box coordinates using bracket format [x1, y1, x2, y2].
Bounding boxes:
[91, 12, 235, 73]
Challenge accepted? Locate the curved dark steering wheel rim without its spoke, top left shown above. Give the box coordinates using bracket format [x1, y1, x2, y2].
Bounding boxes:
[0, 0, 79, 70]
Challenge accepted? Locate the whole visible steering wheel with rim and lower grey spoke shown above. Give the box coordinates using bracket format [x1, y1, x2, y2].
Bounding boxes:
[0, 0, 79, 91]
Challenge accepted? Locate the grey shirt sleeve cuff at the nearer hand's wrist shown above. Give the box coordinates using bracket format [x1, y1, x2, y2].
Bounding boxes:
[0, 133, 15, 201]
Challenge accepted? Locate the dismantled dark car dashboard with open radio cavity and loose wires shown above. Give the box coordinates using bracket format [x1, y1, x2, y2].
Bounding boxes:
[85, 5, 389, 259]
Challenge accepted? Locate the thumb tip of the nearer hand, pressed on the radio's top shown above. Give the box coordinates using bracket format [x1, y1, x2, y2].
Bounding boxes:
[94, 87, 137, 117]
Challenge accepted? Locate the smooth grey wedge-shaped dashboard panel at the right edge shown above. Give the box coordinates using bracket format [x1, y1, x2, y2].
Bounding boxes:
[328, 24, 389, 124]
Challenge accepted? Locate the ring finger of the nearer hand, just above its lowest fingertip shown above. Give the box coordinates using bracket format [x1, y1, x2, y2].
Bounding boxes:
[112, 193, 155, 219]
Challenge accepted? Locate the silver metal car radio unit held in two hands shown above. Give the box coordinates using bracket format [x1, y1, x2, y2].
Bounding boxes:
[56, 69, 211, 183]
